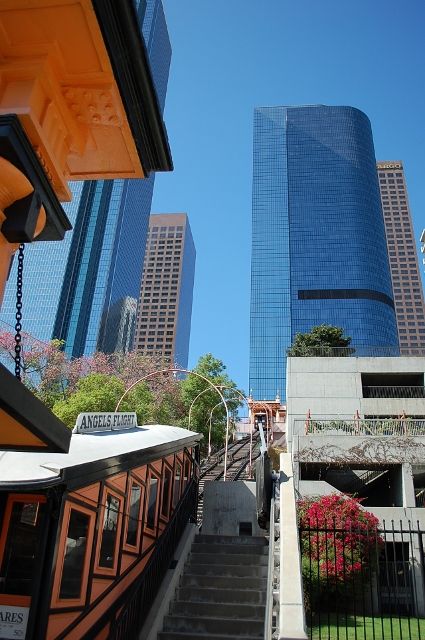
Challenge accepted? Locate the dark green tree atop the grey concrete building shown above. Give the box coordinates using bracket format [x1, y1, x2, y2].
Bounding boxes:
[287, 324, 354, 357]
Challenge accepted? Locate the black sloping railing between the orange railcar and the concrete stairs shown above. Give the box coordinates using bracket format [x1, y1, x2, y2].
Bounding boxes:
[106, 480, 198, 640]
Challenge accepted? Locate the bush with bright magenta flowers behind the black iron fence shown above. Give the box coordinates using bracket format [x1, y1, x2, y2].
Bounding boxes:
[298, 494, 383, 611]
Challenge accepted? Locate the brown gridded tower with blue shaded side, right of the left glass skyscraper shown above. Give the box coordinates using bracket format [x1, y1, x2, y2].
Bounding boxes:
[134, 213, 196, 367]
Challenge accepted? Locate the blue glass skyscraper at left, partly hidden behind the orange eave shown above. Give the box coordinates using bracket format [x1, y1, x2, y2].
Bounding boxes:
[0, 0, 171, 356]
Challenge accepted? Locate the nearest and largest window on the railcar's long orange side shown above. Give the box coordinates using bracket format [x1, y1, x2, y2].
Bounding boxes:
[59, 509, 90, 600]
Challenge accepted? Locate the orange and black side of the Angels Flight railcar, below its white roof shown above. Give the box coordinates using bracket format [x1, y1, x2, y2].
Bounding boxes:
[0, 448, 196, 640]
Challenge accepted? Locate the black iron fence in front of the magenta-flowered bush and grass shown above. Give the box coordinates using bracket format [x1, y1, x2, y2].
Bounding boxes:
[300, 521, 425, 640]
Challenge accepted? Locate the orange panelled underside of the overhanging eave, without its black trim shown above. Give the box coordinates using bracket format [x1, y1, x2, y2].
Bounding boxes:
[0, 0, 143, 200]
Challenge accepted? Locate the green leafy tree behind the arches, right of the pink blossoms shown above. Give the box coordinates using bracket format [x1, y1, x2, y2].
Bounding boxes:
[180, 353, 244, 452]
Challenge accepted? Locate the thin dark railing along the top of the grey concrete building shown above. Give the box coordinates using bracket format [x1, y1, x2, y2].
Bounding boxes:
[287, 345, 425, 358]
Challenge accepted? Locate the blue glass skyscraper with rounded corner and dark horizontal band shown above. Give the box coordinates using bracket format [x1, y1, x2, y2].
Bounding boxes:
[249, 105, 398, 399]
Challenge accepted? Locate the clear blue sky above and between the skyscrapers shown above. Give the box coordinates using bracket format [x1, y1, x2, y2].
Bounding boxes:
[152, 0, 425, 391]
